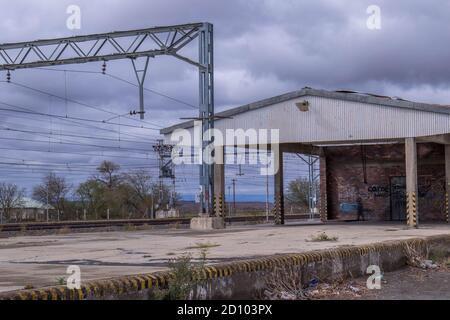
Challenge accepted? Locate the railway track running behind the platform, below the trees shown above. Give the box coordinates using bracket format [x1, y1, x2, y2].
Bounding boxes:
[0, 214, 308, 232]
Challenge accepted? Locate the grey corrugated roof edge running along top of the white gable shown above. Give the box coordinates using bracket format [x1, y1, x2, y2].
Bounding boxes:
[160, 87, 450, 134]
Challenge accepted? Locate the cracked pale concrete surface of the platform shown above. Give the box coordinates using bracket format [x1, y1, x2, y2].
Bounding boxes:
[0, 223, 450, 291]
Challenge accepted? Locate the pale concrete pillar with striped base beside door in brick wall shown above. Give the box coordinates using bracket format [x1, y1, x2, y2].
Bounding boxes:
[405, 138, 419, 228]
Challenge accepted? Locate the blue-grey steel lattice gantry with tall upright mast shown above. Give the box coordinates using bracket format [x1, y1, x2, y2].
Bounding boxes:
[0, 22, 214, 213]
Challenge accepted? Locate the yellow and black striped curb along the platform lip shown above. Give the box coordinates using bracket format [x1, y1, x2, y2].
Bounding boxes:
[0, 235, 450, 300]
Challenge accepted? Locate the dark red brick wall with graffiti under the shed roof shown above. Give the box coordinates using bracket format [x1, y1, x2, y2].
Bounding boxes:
[321, 143, 445, 221]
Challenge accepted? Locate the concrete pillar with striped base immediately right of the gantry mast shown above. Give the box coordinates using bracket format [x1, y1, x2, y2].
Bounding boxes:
[213, 147, 225, 217]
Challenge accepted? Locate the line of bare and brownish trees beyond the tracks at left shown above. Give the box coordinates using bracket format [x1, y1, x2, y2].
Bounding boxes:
[0, 161, 180, 223]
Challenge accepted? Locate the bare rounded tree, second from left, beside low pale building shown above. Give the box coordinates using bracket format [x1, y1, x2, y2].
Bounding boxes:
[33, 173, 71, 218]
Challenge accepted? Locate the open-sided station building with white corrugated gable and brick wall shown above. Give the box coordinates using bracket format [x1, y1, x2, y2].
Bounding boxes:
[161, 87, 450, 227]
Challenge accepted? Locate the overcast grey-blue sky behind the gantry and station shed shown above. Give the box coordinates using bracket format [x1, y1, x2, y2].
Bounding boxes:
[0, 0, 450, 199]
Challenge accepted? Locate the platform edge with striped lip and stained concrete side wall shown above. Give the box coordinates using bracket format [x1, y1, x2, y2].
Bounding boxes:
[0, 234, 450, 300]
